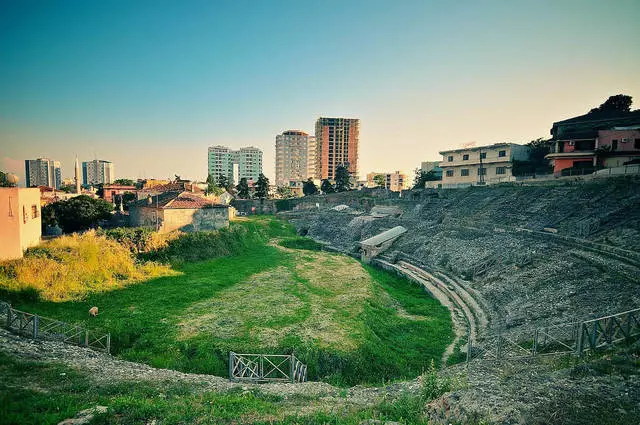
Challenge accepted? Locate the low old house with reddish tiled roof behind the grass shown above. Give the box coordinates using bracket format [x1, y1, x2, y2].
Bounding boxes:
[129, 191, 229, 233]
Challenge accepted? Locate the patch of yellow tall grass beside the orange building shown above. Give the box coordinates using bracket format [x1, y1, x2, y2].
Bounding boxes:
[0, 231, 175, 302]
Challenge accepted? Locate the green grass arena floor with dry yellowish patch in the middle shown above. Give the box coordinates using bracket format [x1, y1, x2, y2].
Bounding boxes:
[3, 217, 453, 385]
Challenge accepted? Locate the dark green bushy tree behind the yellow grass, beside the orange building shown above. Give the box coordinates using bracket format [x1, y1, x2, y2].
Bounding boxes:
[42, 195, 113, 233]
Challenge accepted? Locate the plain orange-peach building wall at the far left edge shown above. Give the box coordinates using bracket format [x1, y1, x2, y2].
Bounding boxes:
[0, 187, 42, 261]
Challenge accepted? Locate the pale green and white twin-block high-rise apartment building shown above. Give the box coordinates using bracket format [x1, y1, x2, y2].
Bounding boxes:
[208, 146, 262, 184]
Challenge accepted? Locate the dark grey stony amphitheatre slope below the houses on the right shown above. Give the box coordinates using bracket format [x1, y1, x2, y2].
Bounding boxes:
[282, 178, 640, 329]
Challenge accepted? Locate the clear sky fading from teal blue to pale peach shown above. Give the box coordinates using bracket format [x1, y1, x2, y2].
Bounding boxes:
[0, 0, 640, 181]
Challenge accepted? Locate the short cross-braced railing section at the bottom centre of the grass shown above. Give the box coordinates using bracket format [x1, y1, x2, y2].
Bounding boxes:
[229, 351, 307, 383]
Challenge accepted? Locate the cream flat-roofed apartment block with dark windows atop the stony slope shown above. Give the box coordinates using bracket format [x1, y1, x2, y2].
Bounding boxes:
[440, 143, 530, 188]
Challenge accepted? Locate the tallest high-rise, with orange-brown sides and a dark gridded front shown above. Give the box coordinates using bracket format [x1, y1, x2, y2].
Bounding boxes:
[315, 117, 360, 180]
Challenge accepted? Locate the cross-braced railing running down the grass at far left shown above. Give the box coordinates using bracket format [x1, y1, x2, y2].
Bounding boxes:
[0, 301, 111, 353]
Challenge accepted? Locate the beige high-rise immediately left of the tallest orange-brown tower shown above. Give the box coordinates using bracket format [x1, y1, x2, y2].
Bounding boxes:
[276, 130, 316, 186]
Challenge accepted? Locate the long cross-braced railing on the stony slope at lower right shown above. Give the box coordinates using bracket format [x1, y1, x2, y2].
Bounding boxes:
[467, 308, 640, 362]
